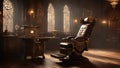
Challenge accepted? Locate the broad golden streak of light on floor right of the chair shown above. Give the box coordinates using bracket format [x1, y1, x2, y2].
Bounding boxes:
[84, 49, 120, 65]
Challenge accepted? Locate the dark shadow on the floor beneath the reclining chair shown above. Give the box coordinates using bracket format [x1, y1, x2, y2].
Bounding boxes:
[56, 57, 97, 68]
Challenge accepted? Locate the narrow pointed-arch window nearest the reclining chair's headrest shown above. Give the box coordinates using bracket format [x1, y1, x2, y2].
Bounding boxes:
[63, 5, 70, 32]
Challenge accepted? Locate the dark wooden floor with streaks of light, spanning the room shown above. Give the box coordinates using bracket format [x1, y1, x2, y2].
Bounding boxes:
[0, 49, 120, 68]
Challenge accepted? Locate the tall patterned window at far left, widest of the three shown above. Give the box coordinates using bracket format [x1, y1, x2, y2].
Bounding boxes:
[3, 0, 13, 32]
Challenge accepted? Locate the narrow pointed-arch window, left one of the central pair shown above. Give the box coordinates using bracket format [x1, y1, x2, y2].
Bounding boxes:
[47, 3, 55, 32]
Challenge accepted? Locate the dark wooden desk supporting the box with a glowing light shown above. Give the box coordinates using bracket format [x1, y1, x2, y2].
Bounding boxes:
[23, 37, 56, 59]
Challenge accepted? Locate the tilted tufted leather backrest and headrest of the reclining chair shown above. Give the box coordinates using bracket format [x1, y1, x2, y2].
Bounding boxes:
[76, 16, 96, 38]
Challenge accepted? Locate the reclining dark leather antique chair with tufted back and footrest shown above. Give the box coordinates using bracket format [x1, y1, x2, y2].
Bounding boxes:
[51, 17, 96, 61]
